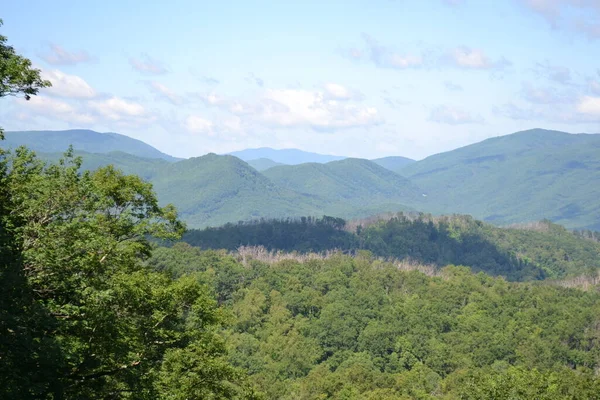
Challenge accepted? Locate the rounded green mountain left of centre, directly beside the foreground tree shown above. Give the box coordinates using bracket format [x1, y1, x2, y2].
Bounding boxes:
[150, 153, 322, 227]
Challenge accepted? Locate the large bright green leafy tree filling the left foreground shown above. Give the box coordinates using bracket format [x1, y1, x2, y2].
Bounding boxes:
[0, 148, 252, 399]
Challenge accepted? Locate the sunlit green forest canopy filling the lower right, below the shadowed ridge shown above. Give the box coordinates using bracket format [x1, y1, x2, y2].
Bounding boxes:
[149, 248, 600, 400]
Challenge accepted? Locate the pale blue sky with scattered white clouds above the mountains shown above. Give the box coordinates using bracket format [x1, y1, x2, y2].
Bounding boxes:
[0, 0, 600, 159]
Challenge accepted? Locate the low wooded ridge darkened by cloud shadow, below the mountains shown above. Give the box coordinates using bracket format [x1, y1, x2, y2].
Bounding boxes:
[183, 214, 600, 280]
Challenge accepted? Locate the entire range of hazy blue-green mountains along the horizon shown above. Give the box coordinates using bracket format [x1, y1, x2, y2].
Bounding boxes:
[2, 129, 600, 229]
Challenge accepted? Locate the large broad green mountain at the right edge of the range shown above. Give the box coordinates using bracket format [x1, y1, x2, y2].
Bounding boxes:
[400, 129, 600, 229]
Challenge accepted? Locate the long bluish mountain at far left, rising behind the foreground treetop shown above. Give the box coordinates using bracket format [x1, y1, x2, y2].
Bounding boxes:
[2, 129, 178, 162]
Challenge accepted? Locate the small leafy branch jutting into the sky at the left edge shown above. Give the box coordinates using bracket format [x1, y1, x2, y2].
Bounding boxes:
[0, 19, 51, 139]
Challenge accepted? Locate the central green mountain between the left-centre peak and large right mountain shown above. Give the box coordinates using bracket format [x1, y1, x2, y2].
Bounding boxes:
[263, 158, 425, 212]
